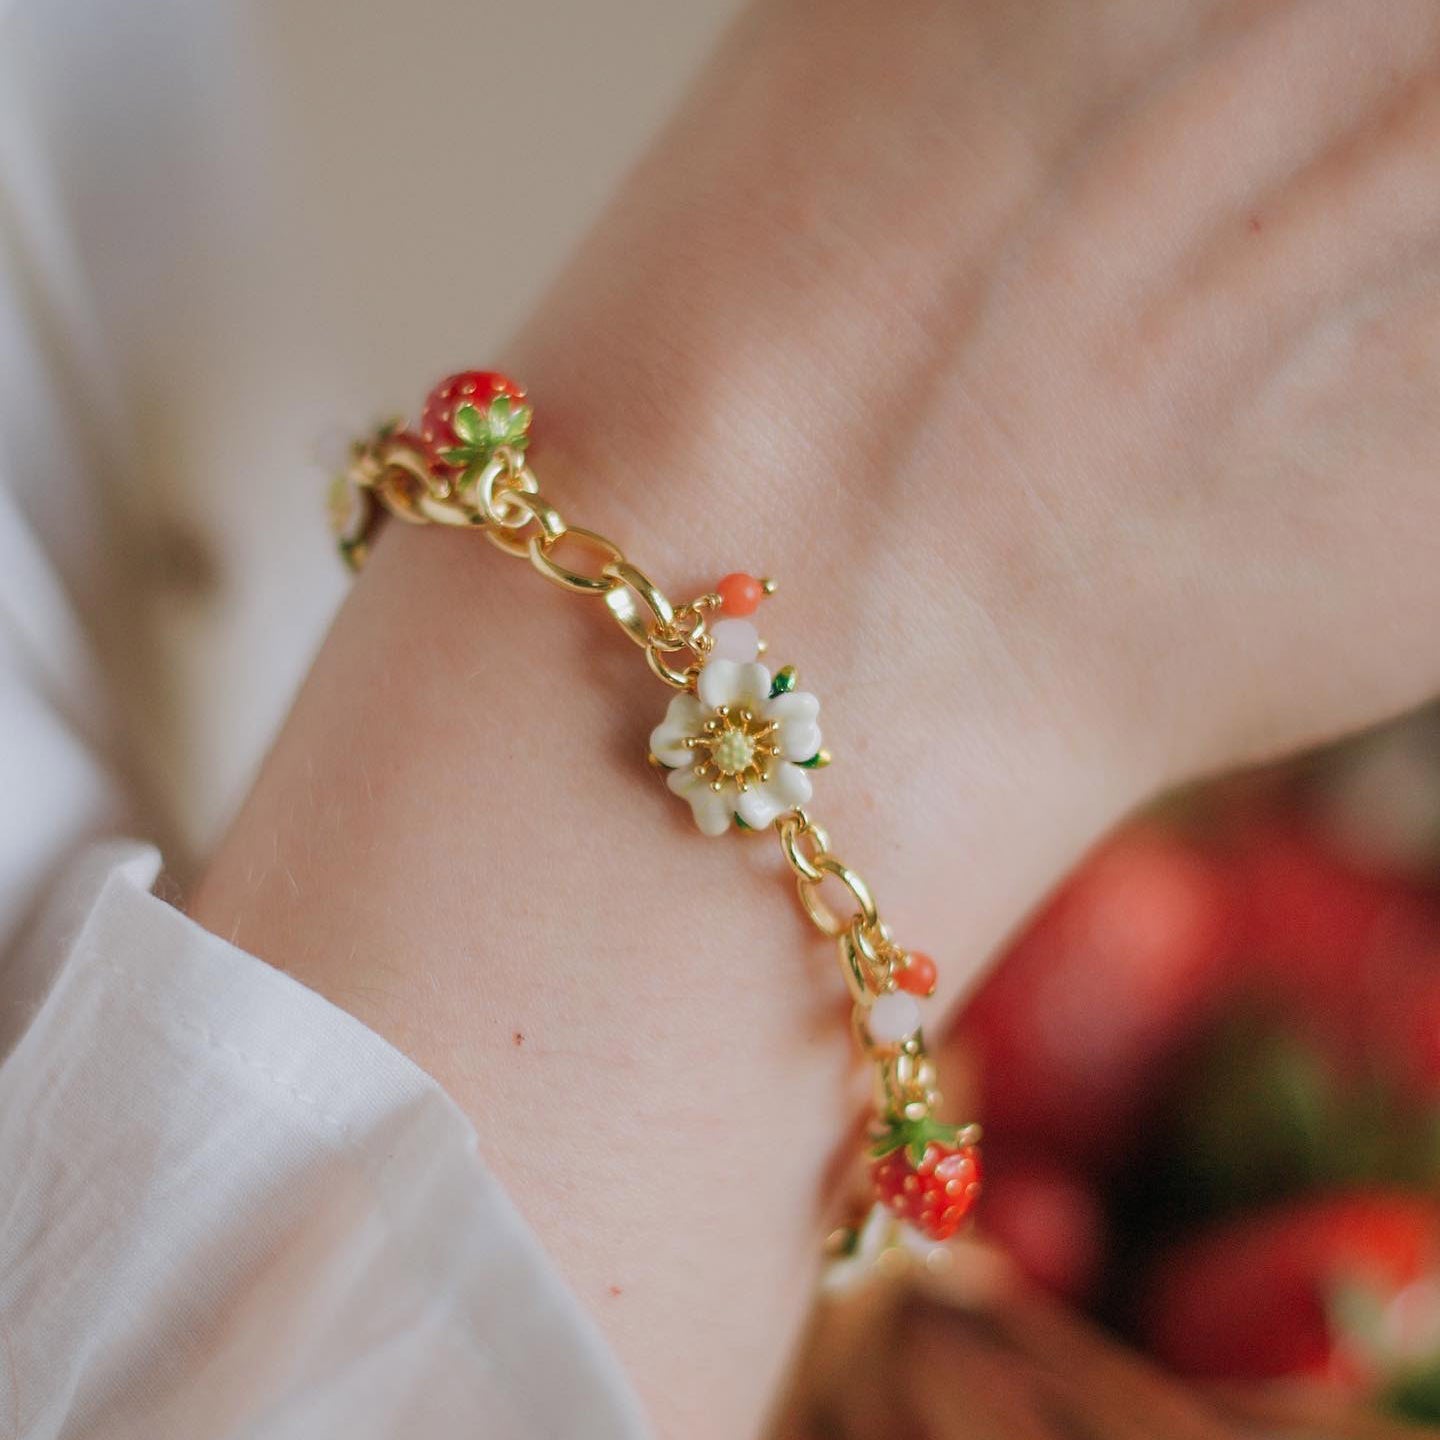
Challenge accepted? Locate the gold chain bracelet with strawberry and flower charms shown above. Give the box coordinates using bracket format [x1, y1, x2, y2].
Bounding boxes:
[330, 370, 981, 1254]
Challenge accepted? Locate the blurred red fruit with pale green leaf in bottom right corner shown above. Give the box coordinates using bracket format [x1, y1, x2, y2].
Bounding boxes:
[1143, 1192, 1440, 1388]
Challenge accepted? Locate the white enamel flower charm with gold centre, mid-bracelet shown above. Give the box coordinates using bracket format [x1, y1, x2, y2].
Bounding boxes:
[649, 639, 824, 835]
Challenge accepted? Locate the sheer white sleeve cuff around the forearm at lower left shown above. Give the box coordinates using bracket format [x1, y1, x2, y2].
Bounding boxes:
[0, 845, 644, 1440]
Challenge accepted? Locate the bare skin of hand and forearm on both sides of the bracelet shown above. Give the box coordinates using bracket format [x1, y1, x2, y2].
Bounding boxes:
[192, 0, 1440, 1440]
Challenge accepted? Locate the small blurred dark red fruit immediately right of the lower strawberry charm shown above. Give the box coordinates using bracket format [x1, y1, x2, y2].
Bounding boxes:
[981, 1156, 1106, 1300]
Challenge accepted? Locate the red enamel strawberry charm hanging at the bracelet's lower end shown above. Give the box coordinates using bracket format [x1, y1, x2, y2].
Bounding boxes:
[870, 1117, 981, 1241]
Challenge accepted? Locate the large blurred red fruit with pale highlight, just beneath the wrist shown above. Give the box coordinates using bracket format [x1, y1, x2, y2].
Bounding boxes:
[960, 827, 1231, 1168]
